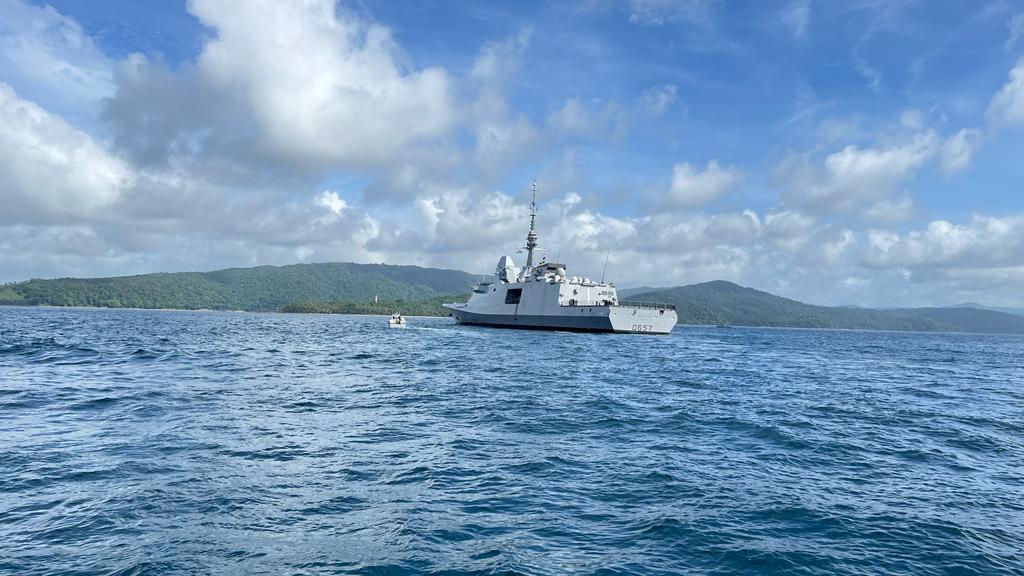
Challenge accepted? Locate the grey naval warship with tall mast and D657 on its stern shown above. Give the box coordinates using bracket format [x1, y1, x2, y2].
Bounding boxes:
[443, 181, 677, 334]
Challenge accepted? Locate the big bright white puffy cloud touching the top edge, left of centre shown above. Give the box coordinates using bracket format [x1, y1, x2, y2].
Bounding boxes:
[197, 0, 454, 164]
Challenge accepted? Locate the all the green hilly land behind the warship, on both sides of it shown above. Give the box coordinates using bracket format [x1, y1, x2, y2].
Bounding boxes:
[0, 262, 1024, 334]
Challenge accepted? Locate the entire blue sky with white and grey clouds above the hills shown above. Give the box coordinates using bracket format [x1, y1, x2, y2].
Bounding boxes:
[0, 0, 1024, 305]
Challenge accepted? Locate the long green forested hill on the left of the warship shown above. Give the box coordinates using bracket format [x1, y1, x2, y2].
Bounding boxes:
[0, 262, 475, 311]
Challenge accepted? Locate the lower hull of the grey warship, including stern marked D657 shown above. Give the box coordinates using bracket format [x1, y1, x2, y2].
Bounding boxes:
[444, 304, 677, 334]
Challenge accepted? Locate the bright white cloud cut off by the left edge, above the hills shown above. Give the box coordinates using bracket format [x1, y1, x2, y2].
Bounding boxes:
[0, 83, 133, 222]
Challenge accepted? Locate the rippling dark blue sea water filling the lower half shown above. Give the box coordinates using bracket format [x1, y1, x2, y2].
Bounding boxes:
[0, 307, 1024, 574]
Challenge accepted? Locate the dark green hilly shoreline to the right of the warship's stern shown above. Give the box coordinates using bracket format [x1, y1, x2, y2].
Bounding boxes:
[630, 281, 1024, 334]
